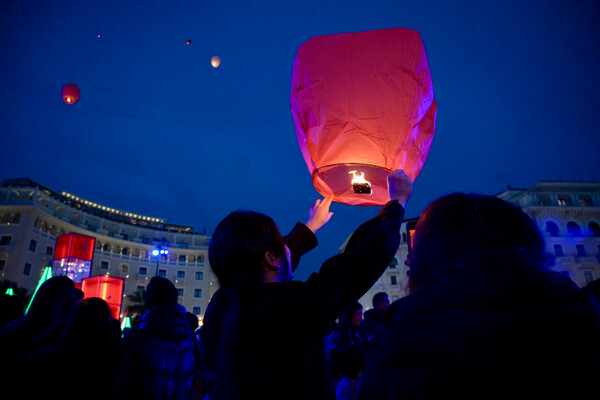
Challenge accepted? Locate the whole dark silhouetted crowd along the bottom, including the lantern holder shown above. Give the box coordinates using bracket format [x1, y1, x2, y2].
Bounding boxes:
[0, 171, 600, 400]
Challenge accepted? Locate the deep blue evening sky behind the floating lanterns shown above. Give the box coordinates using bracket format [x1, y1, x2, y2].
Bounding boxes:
[0, 0, 600, 279]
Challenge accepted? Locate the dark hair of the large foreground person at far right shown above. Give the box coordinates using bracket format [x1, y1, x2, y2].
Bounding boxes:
[409, 193, 551, 289]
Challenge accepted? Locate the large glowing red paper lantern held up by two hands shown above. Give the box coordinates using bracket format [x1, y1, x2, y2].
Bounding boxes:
[290, 28, 437, 206]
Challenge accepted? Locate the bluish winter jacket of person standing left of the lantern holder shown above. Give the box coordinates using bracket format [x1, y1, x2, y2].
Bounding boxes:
[114, 304, 196, 400]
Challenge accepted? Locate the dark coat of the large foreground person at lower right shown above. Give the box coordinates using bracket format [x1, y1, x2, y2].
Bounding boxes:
[360, 266, 600, 399]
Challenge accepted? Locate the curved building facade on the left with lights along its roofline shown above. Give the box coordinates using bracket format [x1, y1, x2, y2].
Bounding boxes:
[0, 179, 217, 318]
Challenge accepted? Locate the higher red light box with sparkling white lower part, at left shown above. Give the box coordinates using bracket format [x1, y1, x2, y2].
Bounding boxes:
[52, 233, 96, 284]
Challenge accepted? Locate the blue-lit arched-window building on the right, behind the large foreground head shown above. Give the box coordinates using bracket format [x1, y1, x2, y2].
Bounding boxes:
[359, 181, 600, 310]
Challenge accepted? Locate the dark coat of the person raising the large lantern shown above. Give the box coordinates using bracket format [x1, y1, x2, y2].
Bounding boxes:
[202, 201, 404, 400]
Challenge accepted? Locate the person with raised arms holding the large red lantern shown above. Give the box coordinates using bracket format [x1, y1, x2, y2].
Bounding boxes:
[202, 170, 412, 400]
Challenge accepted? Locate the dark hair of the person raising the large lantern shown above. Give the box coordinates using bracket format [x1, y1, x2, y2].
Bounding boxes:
[208, 211, 285, 288]
